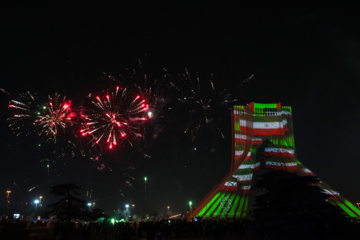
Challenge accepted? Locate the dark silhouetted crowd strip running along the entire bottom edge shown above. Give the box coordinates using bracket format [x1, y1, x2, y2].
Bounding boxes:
[0, 219, 360, 240]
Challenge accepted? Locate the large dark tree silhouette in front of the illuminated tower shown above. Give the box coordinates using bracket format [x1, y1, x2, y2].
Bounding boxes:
[253, 170, 348, 239]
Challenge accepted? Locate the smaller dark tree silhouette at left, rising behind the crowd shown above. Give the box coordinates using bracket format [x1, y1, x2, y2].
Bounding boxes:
[48, 183, 86, 221]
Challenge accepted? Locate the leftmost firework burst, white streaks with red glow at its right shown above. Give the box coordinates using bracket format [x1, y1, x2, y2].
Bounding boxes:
[9, 92, 76, 142]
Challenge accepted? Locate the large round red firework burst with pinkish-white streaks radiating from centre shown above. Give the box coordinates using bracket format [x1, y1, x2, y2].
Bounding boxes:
[80, 86, 149, 149]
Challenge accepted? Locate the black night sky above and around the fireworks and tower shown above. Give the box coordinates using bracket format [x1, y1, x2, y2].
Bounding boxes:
[0, 1, 360, 216]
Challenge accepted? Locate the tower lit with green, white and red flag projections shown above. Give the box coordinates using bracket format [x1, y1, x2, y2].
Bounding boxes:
[187, 102, 360, 219]
